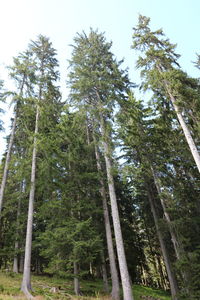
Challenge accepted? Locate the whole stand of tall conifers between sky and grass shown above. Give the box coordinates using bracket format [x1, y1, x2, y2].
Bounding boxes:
[0, 15, 200, 300]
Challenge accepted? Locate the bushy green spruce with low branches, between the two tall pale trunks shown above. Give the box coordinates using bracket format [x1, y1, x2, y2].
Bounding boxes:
[34, 110, 103, 295]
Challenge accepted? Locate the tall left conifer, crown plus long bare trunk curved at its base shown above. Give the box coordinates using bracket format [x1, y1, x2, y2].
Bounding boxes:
[21, 36, 61, 298]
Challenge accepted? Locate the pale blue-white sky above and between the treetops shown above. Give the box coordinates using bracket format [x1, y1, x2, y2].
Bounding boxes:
[0, 0, 200, 155]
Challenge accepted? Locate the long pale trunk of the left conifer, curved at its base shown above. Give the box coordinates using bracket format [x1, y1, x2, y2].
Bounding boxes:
[21, 105, 39, 299]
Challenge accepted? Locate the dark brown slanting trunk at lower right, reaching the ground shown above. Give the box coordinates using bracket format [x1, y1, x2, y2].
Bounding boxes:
[146, 182, 178, 300]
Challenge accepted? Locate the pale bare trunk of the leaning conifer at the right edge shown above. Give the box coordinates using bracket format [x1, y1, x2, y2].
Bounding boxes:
[157, 65, 200, 172]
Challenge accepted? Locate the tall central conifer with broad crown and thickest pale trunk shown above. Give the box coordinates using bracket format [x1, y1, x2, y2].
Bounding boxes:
[69, 30, 133, 300]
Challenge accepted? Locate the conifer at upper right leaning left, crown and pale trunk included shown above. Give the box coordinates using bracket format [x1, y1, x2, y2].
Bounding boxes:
[132, 15, 200, 172]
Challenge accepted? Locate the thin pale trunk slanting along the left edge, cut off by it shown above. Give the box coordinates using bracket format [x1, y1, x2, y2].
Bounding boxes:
[0, 110, 17, 218]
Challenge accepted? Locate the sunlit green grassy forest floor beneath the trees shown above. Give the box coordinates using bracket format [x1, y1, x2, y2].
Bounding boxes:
[0, 272, 171, 300]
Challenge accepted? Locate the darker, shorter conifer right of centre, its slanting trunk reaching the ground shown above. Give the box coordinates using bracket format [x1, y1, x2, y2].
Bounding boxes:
[118, 93, 178, 299]
